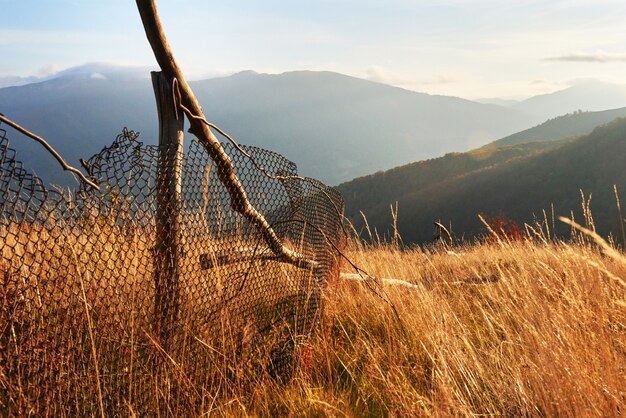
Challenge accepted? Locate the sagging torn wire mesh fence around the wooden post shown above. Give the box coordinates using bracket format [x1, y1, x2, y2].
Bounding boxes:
[0, 129, 344, 416]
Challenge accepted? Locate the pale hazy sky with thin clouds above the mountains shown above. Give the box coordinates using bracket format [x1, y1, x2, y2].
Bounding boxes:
[0, 0, 626, 98]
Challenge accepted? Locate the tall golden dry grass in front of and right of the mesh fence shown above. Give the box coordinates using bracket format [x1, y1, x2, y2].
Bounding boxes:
[0, 217, 626, 417]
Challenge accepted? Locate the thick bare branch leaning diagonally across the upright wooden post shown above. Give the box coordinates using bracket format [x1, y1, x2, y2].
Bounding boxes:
[136, 0, 317, 268]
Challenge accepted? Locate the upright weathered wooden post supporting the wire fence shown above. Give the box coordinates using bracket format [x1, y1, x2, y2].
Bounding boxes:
[152, 72, 183, 351]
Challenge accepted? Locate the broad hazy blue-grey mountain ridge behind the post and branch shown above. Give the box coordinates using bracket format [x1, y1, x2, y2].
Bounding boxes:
[0, 64, 529, 184]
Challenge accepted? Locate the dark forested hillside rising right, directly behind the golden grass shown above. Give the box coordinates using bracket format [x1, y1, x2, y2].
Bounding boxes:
[339, 119, 626, 242]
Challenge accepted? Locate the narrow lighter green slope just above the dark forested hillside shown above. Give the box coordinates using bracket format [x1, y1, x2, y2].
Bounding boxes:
[485, 107, 626, 147]
